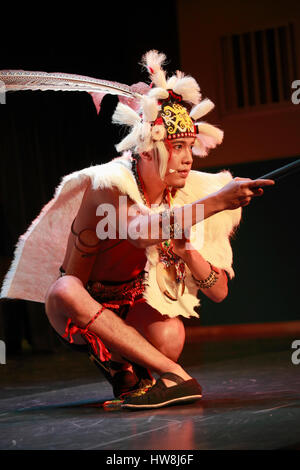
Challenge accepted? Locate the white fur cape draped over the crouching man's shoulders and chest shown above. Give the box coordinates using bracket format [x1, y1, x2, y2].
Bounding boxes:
[0, 156, 241, 317]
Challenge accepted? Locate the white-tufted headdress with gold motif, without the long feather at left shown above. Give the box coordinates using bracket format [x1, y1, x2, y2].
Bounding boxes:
[113, 50, 223, 162]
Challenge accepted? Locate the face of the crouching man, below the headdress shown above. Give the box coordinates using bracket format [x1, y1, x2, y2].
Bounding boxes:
[164, 137, 195, 188]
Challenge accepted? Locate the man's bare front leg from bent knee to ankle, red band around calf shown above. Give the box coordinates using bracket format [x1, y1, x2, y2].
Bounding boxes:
[46, 276, 191, 386]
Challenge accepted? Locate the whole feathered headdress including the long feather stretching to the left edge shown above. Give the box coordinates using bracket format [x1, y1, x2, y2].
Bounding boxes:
[0, 50, 223, 172]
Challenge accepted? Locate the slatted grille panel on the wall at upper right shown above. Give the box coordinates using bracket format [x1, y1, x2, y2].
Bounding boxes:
[221, 24, 297, 112]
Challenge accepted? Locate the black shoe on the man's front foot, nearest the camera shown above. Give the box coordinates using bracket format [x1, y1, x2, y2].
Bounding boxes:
[122, 372, 202, 410]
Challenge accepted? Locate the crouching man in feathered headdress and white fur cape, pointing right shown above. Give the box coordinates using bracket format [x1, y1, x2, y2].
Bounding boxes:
[1, 51, 274, 409]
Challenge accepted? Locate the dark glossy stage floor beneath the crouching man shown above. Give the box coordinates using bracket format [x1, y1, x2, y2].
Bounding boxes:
[0, 338, 300, 450]
